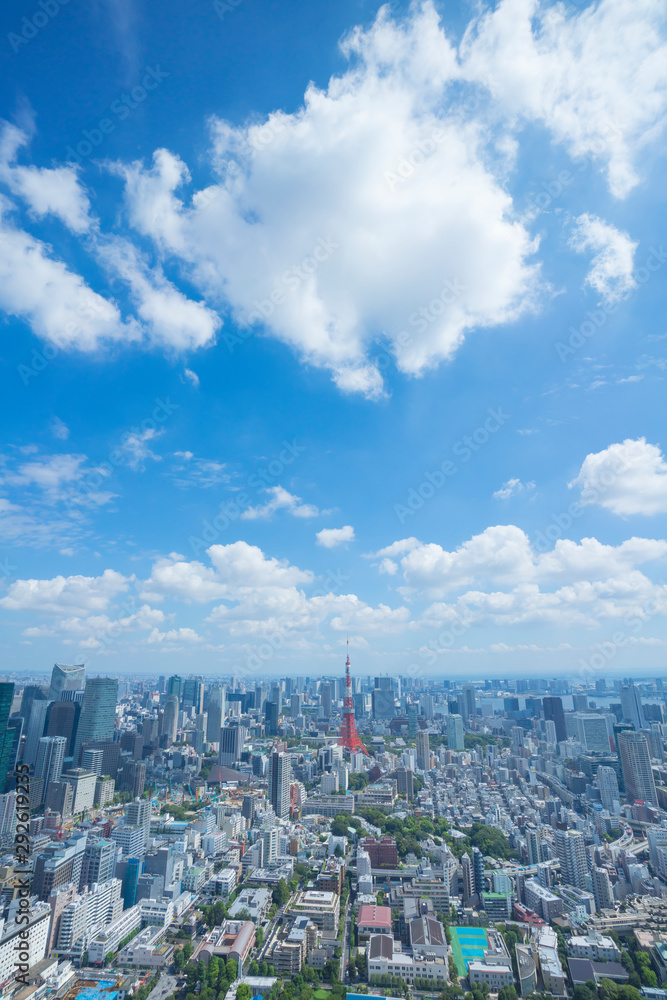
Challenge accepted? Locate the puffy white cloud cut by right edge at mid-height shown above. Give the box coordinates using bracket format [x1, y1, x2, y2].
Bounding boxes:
[569, 438, 667, 516]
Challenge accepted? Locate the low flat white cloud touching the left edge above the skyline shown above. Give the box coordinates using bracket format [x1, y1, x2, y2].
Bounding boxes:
[0, 569, 132, 615]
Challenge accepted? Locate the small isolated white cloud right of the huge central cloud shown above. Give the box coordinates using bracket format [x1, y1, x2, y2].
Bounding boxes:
[570, 214, 637, 303]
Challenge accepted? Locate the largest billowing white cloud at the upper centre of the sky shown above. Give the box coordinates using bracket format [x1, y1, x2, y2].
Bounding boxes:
[116, 3, 538, 397]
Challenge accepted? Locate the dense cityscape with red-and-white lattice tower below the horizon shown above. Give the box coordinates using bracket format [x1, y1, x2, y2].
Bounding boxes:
[0, 652, 667, 1000]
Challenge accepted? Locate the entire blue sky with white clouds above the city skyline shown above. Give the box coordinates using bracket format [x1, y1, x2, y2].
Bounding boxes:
[0, 0, 667, 681]
